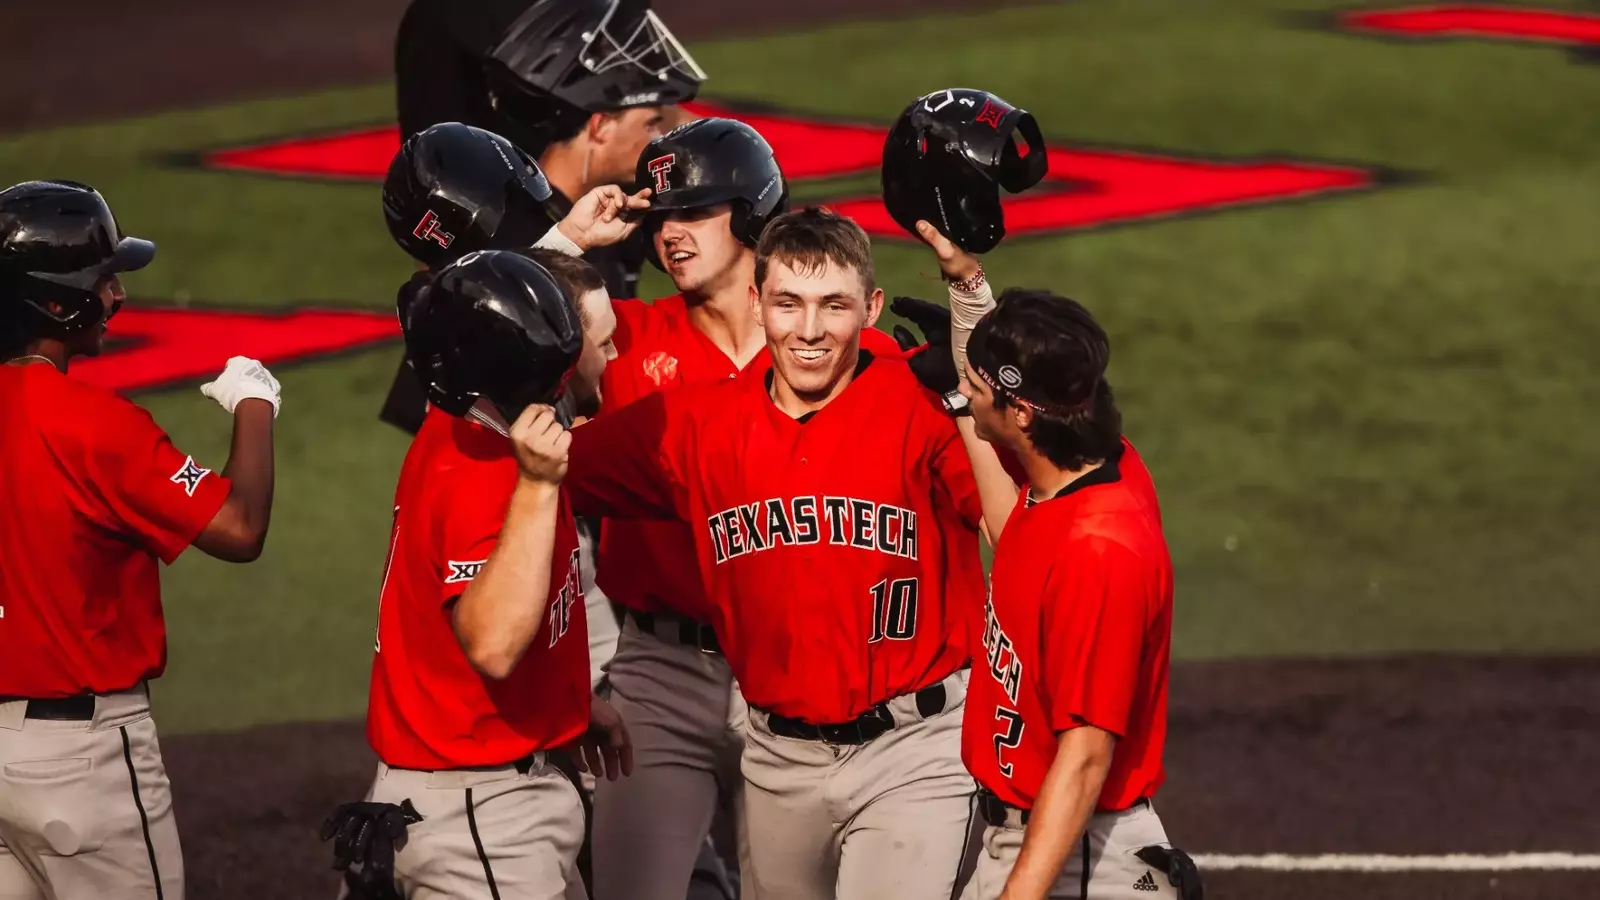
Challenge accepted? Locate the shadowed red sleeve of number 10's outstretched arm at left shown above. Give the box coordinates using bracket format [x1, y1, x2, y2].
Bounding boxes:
[562, 391, 685, 519]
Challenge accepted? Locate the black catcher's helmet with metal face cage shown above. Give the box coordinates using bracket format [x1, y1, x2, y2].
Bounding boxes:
[485, 0, 706, 151]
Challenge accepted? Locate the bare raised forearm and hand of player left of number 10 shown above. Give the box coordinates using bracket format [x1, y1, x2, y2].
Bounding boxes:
[451, 405, 571, 679]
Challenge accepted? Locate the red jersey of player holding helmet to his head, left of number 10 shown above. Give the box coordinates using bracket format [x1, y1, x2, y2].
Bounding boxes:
[366, 408, 589, 769]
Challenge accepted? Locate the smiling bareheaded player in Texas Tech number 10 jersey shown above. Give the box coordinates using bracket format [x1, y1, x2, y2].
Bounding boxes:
[565, 204, 982, 900]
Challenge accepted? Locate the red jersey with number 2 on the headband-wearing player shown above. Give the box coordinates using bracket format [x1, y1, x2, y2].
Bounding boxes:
[962, 440, 1173, 812]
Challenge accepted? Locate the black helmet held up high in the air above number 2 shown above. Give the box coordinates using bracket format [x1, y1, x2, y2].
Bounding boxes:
[883, 88, 1048, 253]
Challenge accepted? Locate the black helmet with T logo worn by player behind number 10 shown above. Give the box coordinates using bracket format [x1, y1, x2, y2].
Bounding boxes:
[634, 119, 789, 269]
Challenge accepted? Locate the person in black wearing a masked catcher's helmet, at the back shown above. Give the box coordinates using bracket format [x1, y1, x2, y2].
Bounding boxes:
[379, 0, 706, 434]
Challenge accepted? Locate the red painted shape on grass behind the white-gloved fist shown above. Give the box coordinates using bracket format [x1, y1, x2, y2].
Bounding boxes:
[72, 304, 400, 392]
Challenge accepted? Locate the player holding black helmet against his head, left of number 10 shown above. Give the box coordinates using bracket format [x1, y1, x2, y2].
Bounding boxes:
[323, 248, 632, 898]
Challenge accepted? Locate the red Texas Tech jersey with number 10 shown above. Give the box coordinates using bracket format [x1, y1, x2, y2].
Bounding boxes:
[565, 354, 982, 724]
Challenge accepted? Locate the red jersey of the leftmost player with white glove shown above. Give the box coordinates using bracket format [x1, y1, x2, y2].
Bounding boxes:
[0, 364, 232, 700]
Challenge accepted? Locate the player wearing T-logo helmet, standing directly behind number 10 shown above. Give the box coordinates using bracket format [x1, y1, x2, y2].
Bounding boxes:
[544, 119, 899, 900]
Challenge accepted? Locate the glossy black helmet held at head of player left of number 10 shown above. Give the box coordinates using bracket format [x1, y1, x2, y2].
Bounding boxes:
[400, 250, 584, 423]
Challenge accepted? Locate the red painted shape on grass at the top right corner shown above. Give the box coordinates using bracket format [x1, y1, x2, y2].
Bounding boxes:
[1339, 3, 1600, 46]
